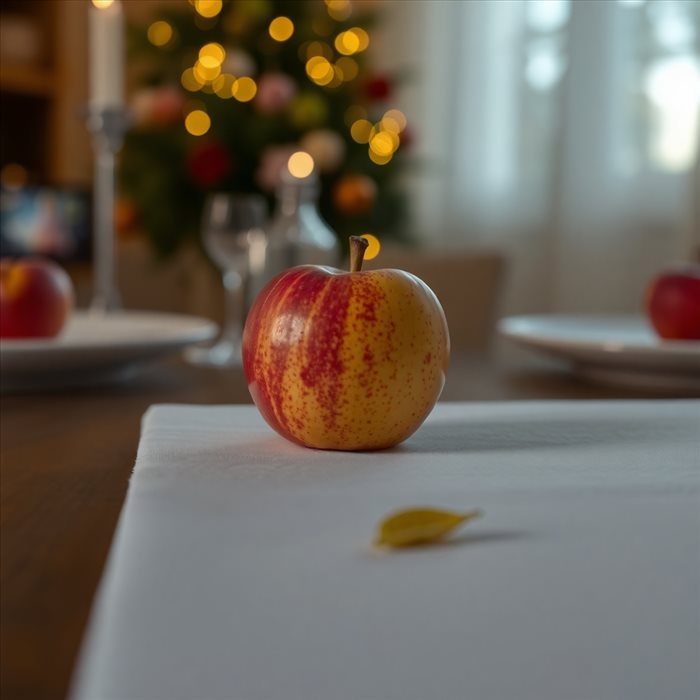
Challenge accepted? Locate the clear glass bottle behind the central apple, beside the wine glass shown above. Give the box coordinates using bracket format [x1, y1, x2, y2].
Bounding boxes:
[247, 170, 340, 308]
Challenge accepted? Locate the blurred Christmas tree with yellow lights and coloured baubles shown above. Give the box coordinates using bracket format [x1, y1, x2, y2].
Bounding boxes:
[120, 0, 408, 255]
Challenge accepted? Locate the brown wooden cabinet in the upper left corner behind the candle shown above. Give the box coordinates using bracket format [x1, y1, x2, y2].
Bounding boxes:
[0, 0, 91, 185]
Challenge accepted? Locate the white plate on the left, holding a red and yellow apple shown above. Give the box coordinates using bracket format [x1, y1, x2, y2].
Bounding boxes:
[0, 311, 217, 391]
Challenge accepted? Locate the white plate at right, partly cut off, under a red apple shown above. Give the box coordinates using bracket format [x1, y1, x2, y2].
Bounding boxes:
[499, 314, 700, 391]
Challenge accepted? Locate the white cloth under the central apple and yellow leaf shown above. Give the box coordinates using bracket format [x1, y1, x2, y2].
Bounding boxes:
[73, 401, 700, 700]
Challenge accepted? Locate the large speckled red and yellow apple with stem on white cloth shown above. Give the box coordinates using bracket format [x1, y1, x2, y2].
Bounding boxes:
[243, 236, 450, 450]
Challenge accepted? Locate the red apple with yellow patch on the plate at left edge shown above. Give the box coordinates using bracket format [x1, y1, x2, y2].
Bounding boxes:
[0, 258, 74, 338]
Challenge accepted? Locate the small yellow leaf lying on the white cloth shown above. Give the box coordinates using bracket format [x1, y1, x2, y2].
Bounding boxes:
[375, 508, 481, 547]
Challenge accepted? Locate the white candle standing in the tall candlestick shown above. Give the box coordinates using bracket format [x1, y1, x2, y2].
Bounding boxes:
[89, 0, 124, 107]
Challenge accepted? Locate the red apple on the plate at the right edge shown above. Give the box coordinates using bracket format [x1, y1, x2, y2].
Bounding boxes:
[645, 265, 700, 340]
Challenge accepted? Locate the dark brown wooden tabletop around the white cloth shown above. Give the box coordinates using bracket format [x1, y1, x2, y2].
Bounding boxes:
[0, 358, 696, 700]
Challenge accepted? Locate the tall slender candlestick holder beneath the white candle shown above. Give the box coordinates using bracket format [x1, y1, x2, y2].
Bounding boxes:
[86, 106, 131, 313]
